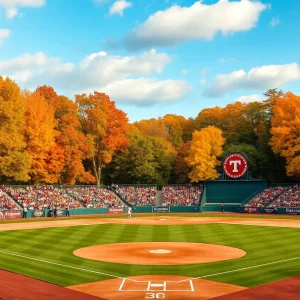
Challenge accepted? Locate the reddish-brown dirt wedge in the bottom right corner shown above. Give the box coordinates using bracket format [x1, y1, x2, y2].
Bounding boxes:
[212, 276, 300, 300]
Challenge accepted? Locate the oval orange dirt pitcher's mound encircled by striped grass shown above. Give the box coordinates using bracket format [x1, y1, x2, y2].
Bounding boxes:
[73, 242, 246, 265]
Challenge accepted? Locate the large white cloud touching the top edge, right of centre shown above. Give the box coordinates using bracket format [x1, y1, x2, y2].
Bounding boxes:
[126, 0, 268, 49]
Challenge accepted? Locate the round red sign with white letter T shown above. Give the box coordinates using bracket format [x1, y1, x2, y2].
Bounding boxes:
[223, 153, 248, 178]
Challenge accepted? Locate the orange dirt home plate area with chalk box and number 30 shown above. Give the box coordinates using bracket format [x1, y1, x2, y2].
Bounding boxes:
[69, 275, 246, 300]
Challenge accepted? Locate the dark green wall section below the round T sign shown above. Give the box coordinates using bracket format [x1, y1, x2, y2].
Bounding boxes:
[201, 180, 268, 212]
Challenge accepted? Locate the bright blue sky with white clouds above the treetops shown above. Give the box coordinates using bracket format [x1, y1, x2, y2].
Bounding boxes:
[0, 0, 300, 122]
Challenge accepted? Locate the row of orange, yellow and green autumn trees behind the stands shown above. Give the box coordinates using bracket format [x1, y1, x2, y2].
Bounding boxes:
[0, 76, 300, 184]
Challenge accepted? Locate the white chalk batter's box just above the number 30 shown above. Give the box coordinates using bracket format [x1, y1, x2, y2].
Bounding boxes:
[119, 278, 195, 292]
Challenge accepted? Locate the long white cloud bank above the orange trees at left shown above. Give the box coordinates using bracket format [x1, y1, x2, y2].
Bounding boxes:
[0, 49, 191, 105]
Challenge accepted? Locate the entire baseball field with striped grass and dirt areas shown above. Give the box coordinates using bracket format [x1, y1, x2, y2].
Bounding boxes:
[0, 214, 300, 300]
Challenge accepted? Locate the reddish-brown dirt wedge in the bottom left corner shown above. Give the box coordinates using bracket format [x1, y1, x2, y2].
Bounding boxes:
[0, 270, 104, 300]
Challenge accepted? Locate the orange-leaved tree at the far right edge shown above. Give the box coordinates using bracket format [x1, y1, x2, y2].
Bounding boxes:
[270, 93, 300, 179]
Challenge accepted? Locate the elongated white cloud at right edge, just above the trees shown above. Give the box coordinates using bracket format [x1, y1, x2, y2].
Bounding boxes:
[205, 63, 300, 97]
